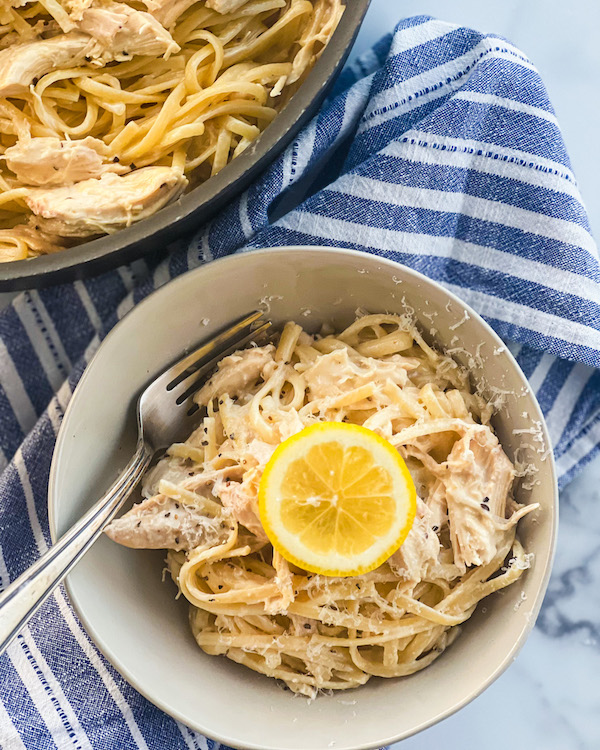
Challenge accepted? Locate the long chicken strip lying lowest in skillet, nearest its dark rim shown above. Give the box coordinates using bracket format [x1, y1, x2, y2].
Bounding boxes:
[25, 167, 187, 237]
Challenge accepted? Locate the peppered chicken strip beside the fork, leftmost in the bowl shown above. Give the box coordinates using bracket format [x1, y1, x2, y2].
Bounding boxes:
[105, 495, 230, 551]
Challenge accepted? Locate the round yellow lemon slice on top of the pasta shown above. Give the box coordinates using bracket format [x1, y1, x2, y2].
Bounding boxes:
[258, 422, 416, 576]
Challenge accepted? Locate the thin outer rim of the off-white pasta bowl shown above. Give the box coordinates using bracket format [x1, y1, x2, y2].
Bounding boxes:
[47, 245, 558, 750]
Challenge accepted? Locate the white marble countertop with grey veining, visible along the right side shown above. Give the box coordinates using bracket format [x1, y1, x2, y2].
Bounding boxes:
[353, 0, 600, 750]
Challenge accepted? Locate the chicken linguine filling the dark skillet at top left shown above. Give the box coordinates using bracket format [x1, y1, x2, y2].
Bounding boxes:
[0, 0, 343, 261]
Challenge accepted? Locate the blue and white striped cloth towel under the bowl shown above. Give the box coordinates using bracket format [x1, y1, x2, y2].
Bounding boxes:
[0, 17, 600, 750]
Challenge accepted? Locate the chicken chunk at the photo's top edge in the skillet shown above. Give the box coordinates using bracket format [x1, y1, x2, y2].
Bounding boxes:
[78, 3, 181, 63]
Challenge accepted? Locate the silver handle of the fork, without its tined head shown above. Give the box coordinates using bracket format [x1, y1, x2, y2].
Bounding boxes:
[0, 440, 152, 654]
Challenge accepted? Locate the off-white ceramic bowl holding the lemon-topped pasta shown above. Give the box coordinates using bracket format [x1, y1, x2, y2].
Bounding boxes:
[49, 247, 557, 750]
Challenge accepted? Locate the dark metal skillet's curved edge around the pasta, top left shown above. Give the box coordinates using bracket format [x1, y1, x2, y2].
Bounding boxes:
[0, 0, 370, 292]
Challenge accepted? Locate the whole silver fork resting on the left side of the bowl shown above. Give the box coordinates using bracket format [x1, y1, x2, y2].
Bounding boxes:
[0, 312, 271, 653]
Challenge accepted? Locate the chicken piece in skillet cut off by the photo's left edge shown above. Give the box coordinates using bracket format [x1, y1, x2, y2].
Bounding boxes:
[0, 31, 94, 96]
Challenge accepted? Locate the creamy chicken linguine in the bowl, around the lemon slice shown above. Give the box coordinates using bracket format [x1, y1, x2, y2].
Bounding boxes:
[107, 315, 537, 697]
